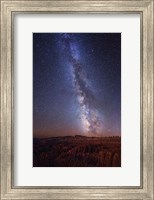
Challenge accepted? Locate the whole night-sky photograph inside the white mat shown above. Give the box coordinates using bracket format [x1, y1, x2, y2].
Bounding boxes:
[33, 33, 121, 167]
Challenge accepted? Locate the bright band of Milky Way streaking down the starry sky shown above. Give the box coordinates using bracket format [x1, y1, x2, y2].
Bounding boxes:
[61, 33, 101, 134]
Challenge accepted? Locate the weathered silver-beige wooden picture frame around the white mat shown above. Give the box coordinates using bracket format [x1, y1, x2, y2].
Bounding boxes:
[0, 0, 154, 200]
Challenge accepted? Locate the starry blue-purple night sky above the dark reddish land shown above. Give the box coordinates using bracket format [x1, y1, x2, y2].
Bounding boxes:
[33, 33, 121, 137]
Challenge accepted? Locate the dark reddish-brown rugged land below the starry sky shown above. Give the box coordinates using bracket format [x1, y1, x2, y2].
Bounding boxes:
[33, 135, 121, 167]
